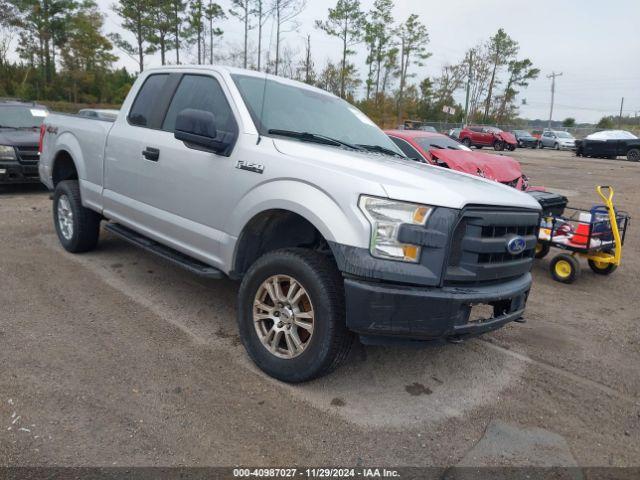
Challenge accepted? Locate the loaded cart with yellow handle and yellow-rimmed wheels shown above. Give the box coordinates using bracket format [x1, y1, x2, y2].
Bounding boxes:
[535, 185, 630, 283]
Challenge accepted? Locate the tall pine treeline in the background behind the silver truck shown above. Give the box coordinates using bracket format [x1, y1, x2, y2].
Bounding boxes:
[0, 0, 540, 126]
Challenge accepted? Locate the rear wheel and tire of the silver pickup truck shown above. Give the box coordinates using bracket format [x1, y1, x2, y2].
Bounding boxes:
[53, 180, 102, 253]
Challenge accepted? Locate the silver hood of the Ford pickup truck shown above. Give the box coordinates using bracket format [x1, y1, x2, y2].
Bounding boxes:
[273, 139, 540, 210]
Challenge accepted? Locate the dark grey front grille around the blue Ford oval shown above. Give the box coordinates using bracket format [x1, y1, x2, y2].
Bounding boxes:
[445, 208, 540, 284]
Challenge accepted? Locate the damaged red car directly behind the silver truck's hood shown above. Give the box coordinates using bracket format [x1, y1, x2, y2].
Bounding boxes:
[385, 130, 532, 191]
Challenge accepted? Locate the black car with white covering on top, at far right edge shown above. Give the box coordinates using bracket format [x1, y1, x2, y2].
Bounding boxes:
[576, 130, 640, 162]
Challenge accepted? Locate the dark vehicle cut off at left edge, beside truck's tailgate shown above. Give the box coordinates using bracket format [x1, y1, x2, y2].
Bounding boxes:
[0, 100, 49, 185]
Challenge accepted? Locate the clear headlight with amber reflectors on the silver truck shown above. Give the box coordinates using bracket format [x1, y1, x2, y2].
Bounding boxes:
[358, 195, 432, 263]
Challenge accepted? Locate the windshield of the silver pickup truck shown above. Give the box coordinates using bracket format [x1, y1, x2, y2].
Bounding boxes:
[232, 75, 404, 156]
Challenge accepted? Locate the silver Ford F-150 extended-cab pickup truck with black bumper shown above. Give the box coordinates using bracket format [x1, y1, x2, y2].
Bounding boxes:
[40, 66, 540, 382]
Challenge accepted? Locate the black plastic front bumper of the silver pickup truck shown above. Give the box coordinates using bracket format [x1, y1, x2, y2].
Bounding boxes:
[344, 273, 531, 343]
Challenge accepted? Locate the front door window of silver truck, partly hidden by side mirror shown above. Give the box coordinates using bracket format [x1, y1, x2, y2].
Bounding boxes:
[162, 75, 237, 133]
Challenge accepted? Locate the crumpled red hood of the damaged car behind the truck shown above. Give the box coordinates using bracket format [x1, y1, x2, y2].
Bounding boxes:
[429, 149, 522, 182]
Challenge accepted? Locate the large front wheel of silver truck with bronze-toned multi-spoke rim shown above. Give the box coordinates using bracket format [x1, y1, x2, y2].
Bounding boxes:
[238, 248, 354, 383]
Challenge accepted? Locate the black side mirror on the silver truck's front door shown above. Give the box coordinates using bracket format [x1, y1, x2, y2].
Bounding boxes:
[174, 108, 230, 153]
